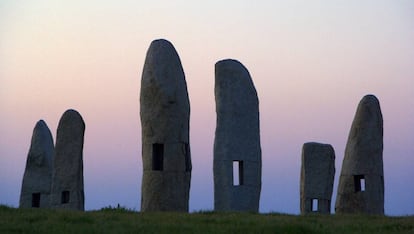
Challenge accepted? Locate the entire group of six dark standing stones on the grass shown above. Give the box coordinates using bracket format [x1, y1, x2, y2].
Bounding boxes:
[20, 39, 384, 214]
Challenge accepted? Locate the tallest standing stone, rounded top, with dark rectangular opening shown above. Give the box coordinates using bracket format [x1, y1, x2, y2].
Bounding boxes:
[140, 39, 191, 212]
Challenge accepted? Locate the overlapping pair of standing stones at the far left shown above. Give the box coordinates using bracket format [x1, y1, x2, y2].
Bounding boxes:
[19, 110, 85, 210]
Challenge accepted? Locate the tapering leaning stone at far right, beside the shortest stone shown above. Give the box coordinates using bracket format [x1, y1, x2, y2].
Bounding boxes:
[335, 95, 384, 215]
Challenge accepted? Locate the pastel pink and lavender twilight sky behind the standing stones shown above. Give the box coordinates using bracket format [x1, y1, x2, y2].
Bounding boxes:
[0, 0, 414, 215]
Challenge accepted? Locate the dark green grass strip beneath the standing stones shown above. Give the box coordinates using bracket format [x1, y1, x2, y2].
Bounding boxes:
[0, 206, 414, 234]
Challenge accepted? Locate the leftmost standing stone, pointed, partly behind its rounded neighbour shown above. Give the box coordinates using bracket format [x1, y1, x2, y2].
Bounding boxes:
[19, 120, 54, 208]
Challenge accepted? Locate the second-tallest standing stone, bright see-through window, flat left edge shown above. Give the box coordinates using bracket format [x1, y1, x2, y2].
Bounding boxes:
[213, 59, 262, 212]
